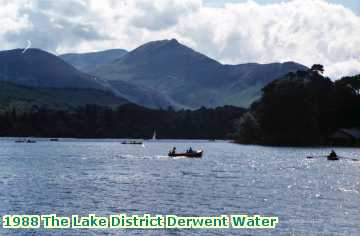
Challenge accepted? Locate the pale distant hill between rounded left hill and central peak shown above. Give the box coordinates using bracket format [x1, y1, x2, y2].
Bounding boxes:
[60, 49, 127, 72]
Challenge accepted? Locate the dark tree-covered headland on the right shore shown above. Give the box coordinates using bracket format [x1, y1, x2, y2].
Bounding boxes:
[233, 65, 360, 146]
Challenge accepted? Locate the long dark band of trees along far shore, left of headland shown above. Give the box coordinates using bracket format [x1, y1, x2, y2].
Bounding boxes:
[0, 104, 246, 139]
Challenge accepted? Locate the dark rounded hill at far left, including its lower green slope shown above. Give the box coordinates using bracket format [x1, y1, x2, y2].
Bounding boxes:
[0, 49, 135, 107]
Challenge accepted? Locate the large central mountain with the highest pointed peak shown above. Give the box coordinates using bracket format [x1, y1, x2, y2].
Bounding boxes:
[90, 39, 306, 108]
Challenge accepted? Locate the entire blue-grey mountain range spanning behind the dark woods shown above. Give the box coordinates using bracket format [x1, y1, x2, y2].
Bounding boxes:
[0, 39, 307, 109]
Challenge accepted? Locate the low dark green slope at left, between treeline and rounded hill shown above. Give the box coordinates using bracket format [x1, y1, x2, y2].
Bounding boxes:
[0, 82, 129, 110]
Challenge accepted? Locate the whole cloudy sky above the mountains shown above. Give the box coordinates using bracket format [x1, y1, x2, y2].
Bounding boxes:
[0, 0, 360, 79]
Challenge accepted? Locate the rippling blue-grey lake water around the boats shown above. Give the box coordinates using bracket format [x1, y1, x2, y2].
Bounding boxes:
[0, 139, 360, 235]
